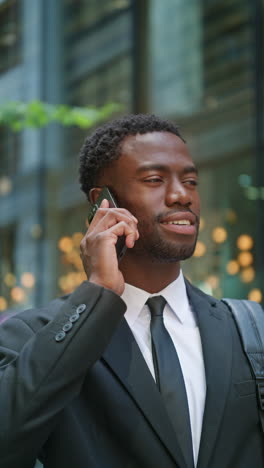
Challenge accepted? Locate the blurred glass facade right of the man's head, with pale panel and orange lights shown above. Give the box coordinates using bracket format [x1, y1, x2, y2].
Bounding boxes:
[149, 0, 263, 297]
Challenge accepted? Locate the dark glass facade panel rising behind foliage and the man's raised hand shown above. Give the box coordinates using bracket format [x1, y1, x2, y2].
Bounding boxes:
[52, 0, 133, 293]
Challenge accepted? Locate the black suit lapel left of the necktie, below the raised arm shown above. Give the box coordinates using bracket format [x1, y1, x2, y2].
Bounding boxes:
[103, 319, 187, 468]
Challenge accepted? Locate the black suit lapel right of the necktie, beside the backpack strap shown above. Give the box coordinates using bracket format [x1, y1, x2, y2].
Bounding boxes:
[187, 283, 232, 468]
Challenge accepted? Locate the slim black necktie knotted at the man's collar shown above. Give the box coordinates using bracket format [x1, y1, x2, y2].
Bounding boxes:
[147, 296, 194, 466]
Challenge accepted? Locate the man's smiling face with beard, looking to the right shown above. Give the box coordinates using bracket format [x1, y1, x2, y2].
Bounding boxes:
[100, 132, 200, 263]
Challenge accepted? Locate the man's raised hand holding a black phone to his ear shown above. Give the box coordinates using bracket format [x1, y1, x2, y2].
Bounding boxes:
[80, 189, 139, 295]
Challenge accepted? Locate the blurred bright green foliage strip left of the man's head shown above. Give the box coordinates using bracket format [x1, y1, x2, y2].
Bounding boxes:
[0, 100, 120, 131]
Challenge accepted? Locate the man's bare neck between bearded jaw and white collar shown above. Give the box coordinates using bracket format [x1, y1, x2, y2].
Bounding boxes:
[120, 252, 180, 294]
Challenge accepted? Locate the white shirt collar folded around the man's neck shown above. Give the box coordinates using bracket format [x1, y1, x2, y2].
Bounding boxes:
[121, 271, 190, 326]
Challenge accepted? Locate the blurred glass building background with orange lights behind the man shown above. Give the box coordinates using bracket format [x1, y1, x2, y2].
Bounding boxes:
[0, 0, 264, 320]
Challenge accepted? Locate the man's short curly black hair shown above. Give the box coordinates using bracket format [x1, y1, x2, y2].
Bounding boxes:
[79, 114, 185, 200]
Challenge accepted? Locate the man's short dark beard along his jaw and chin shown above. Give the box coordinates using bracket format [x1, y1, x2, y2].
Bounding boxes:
[128, 217, 199, 263]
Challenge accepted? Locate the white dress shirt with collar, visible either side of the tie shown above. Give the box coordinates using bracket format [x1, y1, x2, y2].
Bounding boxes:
[122, 272, 206, 465]
